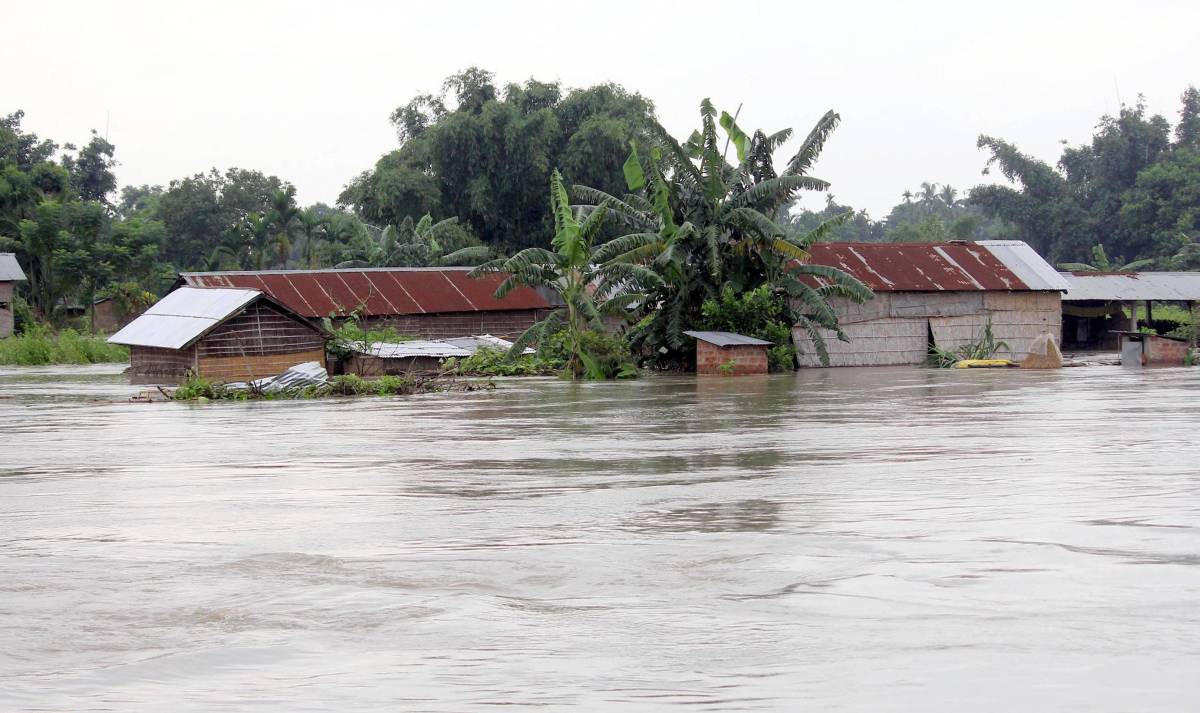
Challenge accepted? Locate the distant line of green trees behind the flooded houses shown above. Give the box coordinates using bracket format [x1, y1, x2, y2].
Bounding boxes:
[0, 67, 1200, 318]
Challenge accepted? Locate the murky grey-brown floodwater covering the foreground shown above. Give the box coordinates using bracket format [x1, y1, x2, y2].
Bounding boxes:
[0, 367, 1200, 712]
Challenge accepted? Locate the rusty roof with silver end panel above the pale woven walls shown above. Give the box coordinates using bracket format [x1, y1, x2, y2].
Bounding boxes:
[809, 240, 1066, 292]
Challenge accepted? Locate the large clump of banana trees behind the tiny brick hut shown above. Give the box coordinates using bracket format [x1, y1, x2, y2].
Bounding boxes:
[575, 100, 871, 361]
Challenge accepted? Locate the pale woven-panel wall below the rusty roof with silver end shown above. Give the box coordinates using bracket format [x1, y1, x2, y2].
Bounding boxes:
[792, 292, 1062, 366]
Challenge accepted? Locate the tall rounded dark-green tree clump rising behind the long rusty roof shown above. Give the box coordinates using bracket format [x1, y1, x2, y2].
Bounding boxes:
[338, 67, 653, 252]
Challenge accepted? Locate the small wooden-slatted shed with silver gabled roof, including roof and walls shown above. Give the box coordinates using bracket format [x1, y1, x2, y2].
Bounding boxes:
[108, 287, 326, 382]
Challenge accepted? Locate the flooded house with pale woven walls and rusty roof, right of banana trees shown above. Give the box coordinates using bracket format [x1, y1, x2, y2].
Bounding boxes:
[793, 240, 1067, 366]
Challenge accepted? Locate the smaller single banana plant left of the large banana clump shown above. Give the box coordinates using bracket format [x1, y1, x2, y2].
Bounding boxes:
[470, 169, 659, 378]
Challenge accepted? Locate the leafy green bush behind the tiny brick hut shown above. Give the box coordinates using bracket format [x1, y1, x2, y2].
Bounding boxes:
[700, 284, 796, 371]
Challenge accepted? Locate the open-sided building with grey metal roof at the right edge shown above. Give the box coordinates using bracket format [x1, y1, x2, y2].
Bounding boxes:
[1062, 272, 1200, 350]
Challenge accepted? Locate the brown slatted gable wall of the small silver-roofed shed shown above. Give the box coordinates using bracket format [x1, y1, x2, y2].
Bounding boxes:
[197, 301, 325, 382]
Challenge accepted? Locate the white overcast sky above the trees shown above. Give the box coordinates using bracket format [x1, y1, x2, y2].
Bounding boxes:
[0, 0, 1200, 217]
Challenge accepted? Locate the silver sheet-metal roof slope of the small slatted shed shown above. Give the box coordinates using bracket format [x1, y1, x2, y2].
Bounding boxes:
[108, 287, 263, 349]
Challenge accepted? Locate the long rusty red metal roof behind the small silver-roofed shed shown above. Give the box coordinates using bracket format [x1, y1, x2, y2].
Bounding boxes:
[179, 268, 553, 318]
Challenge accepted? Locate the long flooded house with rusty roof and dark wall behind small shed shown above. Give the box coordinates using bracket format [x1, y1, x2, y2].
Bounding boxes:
[176, 268, 557, 340]
